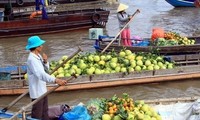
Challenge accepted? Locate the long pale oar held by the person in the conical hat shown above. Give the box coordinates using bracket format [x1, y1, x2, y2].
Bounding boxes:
[101, 9, 140, 53]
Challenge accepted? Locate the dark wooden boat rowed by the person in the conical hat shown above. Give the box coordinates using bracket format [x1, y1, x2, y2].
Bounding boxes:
[95, 37, 200, 55]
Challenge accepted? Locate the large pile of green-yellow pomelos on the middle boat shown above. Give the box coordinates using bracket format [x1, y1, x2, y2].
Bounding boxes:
[50, 49, 174, 77]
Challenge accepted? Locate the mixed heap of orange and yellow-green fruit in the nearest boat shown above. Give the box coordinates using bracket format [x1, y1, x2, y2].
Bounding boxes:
[86, 93, 161, 120]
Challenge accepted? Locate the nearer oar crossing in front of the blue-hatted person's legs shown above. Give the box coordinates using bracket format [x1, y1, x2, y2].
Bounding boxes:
[9, 76, 76, 120]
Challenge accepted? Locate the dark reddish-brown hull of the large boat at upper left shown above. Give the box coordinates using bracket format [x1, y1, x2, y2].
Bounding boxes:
[0, 9, 109, 38]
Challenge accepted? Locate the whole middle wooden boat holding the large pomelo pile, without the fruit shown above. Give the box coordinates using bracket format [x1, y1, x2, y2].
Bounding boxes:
[0, 54, 200, 95]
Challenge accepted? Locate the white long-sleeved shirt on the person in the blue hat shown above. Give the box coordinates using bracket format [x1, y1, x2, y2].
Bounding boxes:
[27, 52, 56, 99]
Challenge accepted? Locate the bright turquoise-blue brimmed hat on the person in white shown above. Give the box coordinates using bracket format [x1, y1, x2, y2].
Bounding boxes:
[26, 36, 45, 50]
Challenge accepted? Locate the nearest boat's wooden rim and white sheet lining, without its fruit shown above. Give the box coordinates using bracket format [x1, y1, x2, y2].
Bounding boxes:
[0, 96, 200, 120]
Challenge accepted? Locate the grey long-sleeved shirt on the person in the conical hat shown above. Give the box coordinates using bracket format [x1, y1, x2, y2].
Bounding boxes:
[117, 12, 130, 29]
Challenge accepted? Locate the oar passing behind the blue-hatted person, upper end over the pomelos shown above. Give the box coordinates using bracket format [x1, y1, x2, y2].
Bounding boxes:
[0, 47, 82, 114]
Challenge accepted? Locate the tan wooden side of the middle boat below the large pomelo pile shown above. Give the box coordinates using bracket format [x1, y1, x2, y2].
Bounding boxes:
[0, 65, 200, 95]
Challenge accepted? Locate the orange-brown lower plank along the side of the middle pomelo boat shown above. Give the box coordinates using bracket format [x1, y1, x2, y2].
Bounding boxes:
[0, 72, 200, 95]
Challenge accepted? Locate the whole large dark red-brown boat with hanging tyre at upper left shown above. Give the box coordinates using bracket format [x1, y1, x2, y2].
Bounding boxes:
[0, 1, 109, 38]
